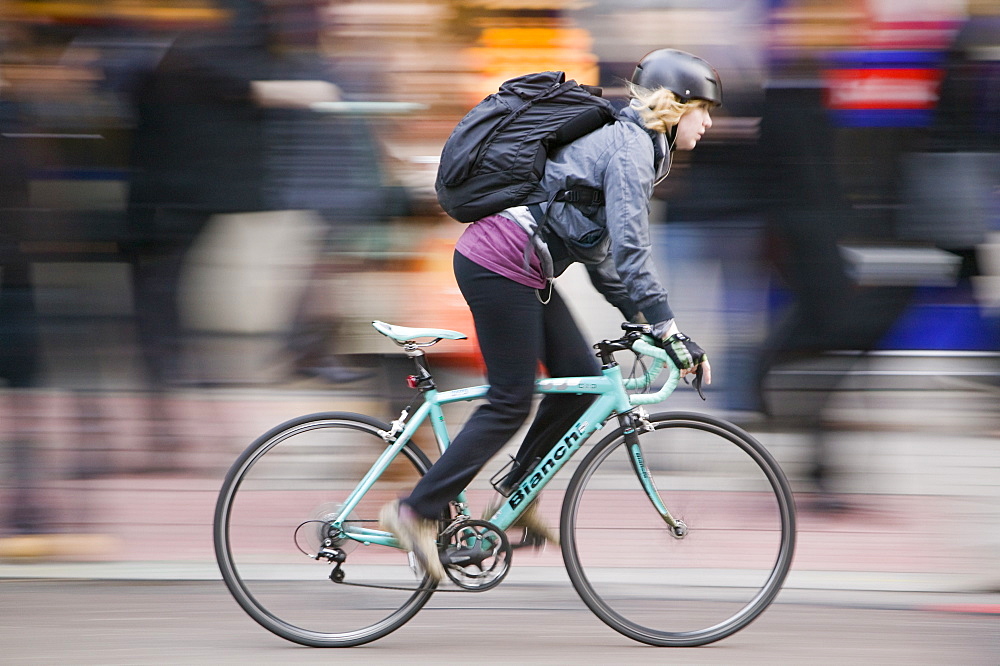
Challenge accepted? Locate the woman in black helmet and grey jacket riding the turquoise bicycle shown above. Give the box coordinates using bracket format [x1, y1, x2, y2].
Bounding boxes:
[381, 49, 722, 581]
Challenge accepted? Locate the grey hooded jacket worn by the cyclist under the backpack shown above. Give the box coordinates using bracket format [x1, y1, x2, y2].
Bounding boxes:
[542, 102, 673, 324]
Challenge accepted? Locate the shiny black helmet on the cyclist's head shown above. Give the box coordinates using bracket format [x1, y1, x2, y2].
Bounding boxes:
[632, 49, 722, 106]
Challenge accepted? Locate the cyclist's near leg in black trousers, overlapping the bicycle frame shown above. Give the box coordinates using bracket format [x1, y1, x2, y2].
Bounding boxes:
[403, 252, 545, 518]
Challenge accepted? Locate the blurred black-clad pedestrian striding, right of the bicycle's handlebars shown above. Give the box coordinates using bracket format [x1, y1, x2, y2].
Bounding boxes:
[758, 54, 911, 508]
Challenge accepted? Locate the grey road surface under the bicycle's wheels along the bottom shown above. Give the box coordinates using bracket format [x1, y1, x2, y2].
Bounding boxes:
[0, 579, 1000, 666]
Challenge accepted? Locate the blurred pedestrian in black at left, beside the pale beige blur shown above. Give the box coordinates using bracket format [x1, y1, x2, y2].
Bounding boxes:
[127, 0, 280, 467]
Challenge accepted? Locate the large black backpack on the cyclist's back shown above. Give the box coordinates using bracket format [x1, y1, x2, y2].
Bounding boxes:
[434, 72, 615, 222]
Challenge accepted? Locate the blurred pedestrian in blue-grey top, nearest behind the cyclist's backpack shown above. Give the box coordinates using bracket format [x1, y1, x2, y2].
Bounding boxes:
[257, 0, 409, 384]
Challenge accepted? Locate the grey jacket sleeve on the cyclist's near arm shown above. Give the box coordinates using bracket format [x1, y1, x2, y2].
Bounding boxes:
[591, 128, 674, 322]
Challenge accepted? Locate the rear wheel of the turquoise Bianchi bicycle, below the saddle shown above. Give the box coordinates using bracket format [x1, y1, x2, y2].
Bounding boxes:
[214, 413, 433, 647]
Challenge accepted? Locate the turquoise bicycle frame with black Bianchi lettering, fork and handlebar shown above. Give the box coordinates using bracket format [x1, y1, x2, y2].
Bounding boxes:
[331, 340, 680, 548]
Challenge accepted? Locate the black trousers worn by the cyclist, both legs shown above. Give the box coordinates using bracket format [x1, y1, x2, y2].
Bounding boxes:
[403, 252, 600, 518]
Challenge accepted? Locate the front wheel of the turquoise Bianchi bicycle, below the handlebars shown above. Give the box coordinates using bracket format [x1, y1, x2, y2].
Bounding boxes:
[561, 412, 795, 647]
